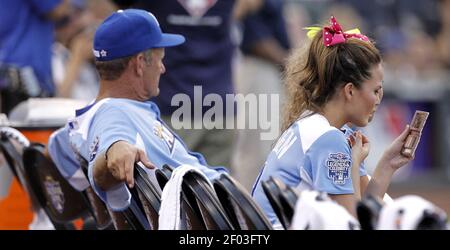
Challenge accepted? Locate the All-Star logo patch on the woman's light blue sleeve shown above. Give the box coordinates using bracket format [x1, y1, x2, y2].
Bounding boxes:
[326, 153, 352, 185]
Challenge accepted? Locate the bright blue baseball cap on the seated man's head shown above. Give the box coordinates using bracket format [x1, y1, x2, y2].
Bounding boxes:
[93, 9, 185, 61]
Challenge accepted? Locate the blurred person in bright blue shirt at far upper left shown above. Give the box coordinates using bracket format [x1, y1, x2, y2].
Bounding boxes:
[0, 0, 69, 113]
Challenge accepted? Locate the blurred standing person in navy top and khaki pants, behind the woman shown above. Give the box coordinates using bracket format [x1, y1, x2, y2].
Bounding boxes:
[232, 0, 290, 190]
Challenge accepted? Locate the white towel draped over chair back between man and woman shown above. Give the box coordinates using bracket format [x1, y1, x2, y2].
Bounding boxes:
[158, 164, 212, 230]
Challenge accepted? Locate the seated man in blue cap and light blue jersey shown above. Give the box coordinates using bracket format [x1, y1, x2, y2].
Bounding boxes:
[64, 9, 227, 211]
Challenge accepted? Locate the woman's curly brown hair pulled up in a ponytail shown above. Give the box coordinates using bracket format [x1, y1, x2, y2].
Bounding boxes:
[282, 28, 381, 131]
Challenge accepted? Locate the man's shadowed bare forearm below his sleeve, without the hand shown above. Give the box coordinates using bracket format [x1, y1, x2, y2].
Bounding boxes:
[92, 153, 121, 190]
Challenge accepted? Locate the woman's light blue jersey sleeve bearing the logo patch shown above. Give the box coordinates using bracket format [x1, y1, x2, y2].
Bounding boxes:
[305, 130, 354, 194]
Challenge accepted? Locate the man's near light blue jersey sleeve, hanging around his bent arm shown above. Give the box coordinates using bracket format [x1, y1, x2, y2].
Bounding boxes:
[88, 105, 137, 211]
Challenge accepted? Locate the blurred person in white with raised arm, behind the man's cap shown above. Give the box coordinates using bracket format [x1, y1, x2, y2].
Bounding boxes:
[52, 0, 98, 101]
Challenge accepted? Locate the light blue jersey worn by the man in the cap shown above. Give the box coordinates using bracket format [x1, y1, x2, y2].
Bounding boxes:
[70, 98, 226, 211]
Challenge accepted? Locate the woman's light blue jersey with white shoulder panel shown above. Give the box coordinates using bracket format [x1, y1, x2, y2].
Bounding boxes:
[252, 114, 366, 225]
